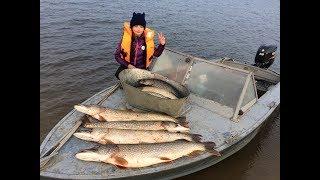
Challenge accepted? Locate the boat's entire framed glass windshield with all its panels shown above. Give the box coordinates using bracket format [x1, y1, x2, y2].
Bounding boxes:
[152, 50, 257, 117]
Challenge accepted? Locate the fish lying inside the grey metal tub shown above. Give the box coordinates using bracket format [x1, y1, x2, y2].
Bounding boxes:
[139, 79, 180, 97]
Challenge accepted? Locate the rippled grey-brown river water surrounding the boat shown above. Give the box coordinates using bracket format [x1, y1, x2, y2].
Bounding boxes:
[40, 0, 280, 179]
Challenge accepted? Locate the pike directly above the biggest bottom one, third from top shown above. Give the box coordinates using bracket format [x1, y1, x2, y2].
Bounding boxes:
[74, 128, 201, 144]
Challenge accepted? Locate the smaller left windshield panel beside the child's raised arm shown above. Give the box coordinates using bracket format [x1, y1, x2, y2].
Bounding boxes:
[151, 50, 191, 83]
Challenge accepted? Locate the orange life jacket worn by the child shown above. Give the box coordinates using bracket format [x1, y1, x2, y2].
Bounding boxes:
[121, 22, 154, 67]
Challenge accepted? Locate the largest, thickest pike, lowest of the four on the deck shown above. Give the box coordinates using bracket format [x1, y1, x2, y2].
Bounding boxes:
[76, 140, 220, 168]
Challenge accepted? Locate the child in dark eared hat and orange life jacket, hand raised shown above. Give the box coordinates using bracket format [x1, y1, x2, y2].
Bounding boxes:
[114, 12, 166, 79]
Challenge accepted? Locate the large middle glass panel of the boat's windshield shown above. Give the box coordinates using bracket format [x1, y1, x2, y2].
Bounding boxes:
[187, 61, 248, 110]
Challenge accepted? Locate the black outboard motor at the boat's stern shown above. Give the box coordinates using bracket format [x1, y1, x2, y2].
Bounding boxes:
[253, 45, 277, 69]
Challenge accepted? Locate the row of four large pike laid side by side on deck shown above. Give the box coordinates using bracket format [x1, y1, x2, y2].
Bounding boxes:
[74, 105, 220, 168]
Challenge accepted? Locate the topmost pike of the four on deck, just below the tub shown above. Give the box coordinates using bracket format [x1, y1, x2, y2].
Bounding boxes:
[74, 104, 186, 124]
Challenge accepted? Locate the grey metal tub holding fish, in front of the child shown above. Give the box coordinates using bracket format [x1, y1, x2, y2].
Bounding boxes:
[119, 69, 190, 117]
